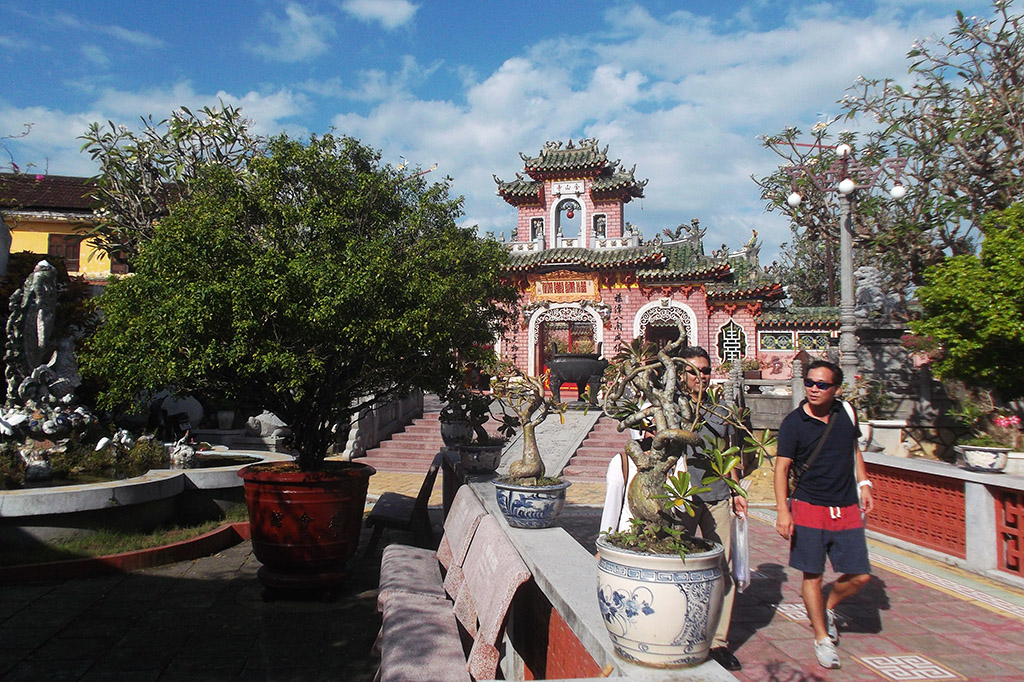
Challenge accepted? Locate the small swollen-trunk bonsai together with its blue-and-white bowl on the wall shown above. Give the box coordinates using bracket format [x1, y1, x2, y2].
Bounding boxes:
[492, 369, 569, 528]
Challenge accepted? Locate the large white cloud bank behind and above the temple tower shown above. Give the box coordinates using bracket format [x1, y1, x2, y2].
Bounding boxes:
[319, 5, 966, 261]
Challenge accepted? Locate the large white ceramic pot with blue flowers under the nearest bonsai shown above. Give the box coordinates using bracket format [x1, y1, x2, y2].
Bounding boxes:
[597, 538, 725, 668]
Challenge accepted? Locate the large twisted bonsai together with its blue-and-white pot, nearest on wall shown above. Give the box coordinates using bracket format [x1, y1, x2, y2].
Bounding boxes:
[597, 329, 772, 668]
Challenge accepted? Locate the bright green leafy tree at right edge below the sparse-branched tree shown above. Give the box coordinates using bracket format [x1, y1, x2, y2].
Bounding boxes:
[910, 204, 1024, 400]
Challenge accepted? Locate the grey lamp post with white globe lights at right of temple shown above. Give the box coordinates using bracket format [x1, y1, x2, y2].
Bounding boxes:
[786, 142, 906, 382]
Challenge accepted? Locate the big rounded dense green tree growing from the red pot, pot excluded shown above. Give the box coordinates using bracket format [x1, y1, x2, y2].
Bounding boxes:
[82, 135, 516, 468]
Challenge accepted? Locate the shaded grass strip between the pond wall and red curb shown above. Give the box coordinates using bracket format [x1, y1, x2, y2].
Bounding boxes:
[0, 505, 249, 566]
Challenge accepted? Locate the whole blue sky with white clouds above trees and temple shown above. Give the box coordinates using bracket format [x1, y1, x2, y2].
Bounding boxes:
[0, 0, 992, 263]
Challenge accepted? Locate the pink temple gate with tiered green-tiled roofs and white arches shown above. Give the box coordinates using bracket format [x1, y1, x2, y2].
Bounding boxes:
[495, 139, 836, 379]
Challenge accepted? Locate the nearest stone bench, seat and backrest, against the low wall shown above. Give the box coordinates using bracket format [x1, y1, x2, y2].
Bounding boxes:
[379, 507, 530, 682]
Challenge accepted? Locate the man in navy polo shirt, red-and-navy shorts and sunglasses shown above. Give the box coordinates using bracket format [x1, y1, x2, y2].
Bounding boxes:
[774, 360, 874, 668]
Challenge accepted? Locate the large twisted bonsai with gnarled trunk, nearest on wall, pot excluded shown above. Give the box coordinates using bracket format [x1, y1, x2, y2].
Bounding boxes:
[604, 324, 773, 555]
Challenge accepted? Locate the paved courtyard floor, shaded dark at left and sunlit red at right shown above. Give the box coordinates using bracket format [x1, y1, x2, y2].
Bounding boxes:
[0, 473, 1024, 682]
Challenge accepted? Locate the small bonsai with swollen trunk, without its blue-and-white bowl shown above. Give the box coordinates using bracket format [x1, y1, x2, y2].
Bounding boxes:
[492, 368, 566, 485]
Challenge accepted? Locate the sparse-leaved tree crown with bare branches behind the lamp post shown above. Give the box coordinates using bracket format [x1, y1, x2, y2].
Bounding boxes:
[754, 0, 1024, 301]
